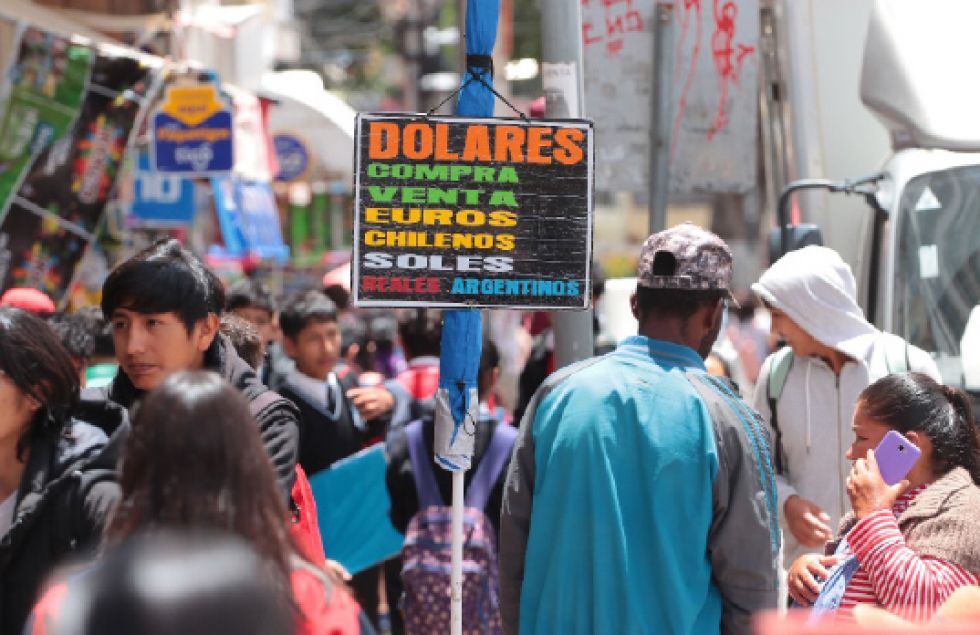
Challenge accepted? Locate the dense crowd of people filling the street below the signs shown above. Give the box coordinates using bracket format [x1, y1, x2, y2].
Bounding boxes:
[0, 224, 980, 635]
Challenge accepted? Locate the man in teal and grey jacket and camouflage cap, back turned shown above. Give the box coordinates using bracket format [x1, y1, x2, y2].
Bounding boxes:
[500, 224, 779, 635]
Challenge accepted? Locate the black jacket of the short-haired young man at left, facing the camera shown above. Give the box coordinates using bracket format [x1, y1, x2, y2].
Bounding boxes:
[80, 335, 299, 497]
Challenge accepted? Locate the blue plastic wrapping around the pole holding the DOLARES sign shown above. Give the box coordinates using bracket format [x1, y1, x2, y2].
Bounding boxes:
[435, 0, 500, 471]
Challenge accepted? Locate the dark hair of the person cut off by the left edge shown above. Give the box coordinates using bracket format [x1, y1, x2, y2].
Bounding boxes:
[0, 307, 79, 459]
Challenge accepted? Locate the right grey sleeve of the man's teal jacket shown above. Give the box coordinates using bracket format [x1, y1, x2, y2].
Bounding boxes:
[690, 374, 780, 635]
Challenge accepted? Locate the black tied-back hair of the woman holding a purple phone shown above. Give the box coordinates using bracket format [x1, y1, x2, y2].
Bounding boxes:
[858, 373, 980, 485]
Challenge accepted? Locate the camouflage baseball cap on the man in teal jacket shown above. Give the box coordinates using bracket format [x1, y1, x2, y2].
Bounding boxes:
[637, 223, 734, 299]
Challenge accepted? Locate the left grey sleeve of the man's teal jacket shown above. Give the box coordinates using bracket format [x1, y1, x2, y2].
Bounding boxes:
[499, 390, 542, 635]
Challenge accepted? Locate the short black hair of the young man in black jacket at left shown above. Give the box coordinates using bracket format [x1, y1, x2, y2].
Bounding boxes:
[102, 239, 225, 333]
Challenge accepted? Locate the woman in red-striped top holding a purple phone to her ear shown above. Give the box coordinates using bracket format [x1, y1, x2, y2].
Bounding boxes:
[788, 373, 980, 621]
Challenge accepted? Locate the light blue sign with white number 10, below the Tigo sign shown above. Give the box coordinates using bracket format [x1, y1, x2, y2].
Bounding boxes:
[130, 152, 194, 227]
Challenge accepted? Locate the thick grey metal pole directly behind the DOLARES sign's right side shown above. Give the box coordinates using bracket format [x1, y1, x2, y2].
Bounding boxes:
[541, 0, 594, 368]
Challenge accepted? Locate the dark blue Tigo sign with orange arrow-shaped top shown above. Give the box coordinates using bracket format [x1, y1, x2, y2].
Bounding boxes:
[151, 84, 234, 176]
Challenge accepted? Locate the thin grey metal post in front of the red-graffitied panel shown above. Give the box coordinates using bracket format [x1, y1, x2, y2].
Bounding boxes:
[649, 2, 674, 234]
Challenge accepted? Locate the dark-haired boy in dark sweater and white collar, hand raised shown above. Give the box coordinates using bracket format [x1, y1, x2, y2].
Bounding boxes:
[279, 291, 406, 475]
